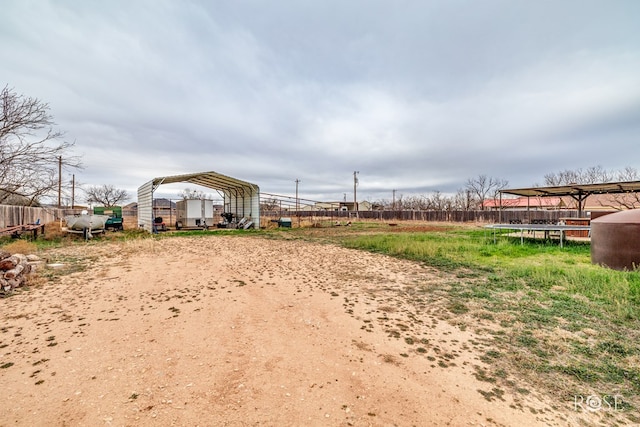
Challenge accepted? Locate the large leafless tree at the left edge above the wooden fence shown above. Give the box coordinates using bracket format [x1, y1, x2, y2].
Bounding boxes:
[0, 86, 80, 204]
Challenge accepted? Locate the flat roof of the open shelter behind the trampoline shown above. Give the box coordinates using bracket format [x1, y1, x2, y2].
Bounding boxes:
[500, 181, 640, 197]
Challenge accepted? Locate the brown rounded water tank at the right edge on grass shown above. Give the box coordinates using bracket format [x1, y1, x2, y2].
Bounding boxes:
[591, 209, 640, 270]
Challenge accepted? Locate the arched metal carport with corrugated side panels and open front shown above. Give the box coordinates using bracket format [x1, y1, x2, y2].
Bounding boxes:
[138, 172, 260, 232]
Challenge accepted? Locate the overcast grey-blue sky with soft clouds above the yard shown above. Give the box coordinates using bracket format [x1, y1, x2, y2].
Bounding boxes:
[0, 0, 640, 204]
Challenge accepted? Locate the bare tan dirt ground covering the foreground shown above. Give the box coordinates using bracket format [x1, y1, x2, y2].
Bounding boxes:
[0, 236, 596, 426]
